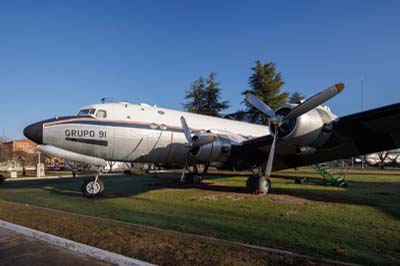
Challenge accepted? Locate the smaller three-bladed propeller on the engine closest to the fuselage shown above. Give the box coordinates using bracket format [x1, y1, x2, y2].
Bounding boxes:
[181, 116, 218, 181]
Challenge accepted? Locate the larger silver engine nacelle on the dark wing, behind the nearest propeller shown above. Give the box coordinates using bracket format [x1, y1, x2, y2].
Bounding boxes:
[270, 105, 336, 149]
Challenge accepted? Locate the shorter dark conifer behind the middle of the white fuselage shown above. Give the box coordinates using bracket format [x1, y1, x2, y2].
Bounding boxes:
[184, 72, 229, 116]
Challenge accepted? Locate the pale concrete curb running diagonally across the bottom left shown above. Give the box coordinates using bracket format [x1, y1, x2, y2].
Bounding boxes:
[0, 220, 154, 266]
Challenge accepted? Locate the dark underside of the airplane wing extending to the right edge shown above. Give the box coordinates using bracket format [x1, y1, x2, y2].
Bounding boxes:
[238, 103, 400, 170]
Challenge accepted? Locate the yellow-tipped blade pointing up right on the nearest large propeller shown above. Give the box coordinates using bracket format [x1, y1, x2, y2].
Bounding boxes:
[284, 83, 344, 120]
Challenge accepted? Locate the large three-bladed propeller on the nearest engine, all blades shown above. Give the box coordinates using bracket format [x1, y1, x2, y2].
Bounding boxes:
[246, 83, 344, 177]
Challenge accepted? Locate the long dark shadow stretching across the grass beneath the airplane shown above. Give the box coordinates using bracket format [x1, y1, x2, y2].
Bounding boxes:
[0, 173, 400, 219]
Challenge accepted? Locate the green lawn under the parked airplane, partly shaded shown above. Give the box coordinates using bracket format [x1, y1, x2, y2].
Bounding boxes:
[0, 170, 400, 265]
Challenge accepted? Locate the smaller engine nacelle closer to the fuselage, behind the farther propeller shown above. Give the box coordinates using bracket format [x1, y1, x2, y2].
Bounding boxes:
[192, 135, 232, 163]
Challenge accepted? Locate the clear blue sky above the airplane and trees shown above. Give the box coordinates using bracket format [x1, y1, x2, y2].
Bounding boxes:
[0, 0, 400, 138]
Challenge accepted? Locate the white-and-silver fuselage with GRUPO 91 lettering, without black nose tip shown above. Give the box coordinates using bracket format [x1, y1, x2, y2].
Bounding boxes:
[42, 103, 269, 164]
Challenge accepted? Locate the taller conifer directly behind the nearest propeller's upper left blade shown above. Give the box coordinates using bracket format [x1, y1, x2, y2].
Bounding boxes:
[242, 60, 289, 125]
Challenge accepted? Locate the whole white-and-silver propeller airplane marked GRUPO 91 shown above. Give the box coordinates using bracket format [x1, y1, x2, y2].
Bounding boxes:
[24, 83, 400, 197]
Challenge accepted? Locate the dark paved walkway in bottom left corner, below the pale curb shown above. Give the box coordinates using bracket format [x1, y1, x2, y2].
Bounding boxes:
[0, 228, 111, 266]
